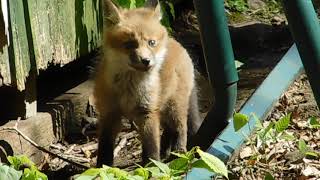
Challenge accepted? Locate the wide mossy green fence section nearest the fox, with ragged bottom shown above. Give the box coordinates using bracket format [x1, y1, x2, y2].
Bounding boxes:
[28, 0, 102, 69]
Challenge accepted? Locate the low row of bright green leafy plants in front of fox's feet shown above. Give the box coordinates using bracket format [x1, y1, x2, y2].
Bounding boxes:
[76, 147, 228, 180]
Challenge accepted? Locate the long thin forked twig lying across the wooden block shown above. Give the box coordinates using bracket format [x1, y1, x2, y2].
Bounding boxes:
[0, 125, 90, 169]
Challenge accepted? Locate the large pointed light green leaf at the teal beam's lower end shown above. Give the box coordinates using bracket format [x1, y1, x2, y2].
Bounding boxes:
[197, 148, 228, 178]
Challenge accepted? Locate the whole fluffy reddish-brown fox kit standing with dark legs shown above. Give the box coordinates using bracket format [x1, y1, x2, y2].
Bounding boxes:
[94, 0, 201, 166]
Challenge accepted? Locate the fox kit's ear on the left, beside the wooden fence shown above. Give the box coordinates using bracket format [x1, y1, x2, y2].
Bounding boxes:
[103, 0, 121, 26]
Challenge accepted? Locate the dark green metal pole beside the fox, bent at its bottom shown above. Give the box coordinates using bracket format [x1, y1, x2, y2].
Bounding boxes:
[189, 0, 238, 148]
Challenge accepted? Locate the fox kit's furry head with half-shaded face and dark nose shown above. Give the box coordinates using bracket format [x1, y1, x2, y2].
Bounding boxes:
[104, 0, 168, 72]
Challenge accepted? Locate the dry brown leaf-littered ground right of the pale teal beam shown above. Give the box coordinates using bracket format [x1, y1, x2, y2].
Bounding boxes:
[228, 74, 320, 180]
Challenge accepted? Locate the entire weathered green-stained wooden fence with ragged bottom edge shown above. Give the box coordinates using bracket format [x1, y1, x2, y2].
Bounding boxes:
[0, 0, 103, 91]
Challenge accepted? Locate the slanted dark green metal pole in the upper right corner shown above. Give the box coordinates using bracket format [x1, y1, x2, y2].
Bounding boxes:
[283, 0, 320, 107]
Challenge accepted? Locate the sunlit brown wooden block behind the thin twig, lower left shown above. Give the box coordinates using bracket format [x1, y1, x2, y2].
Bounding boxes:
[0, 113, 55, 163]
